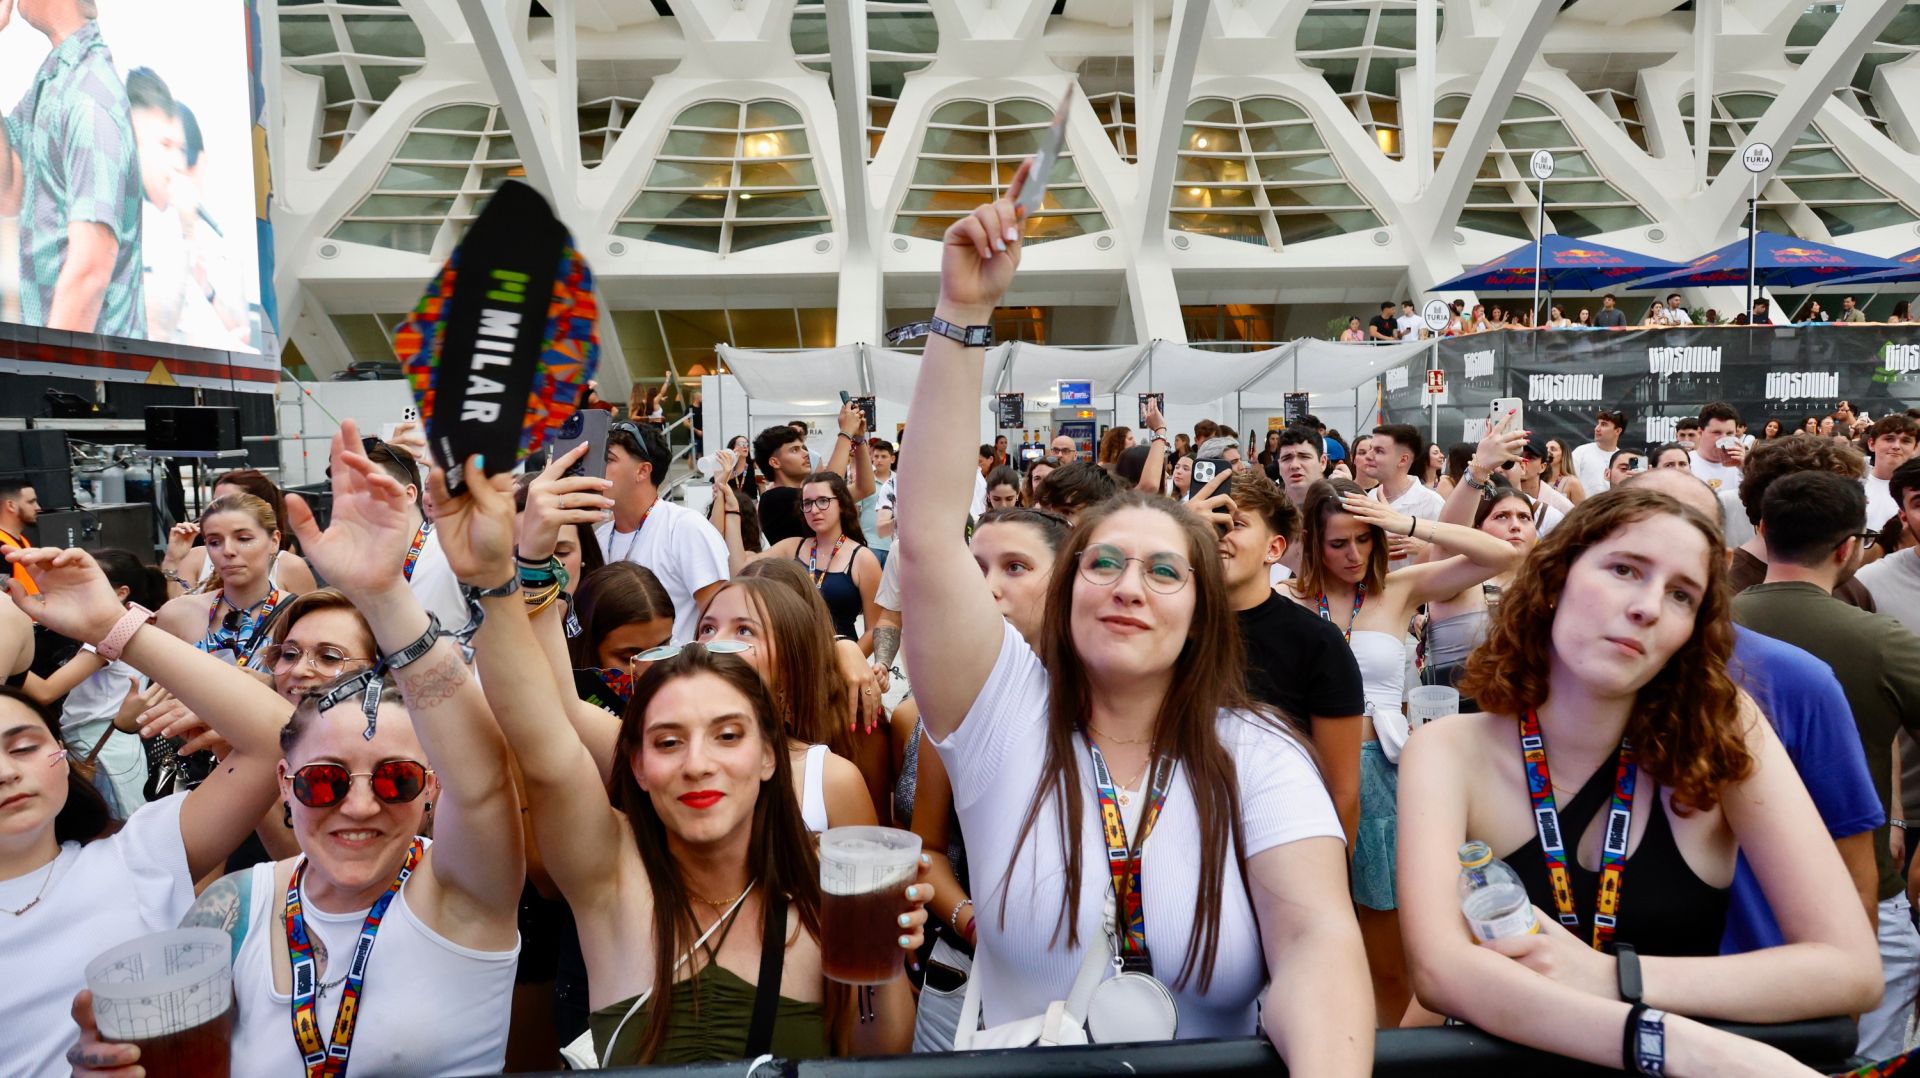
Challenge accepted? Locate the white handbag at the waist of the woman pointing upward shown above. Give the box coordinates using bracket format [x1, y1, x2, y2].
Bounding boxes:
[954, 890, 1179, 1051]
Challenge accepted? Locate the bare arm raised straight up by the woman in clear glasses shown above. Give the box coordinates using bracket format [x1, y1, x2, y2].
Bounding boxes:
[899, 161, 1033, 740]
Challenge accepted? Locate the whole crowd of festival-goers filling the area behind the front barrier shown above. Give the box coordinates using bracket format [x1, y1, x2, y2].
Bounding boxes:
[0, 177, 1920, 1078]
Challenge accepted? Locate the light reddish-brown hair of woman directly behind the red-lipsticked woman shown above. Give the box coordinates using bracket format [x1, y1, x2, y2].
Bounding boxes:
[707, 557, 852, 759]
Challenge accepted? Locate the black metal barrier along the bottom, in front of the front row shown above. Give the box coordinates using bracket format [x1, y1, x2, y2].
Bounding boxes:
[514, 1018, 1857, 1078]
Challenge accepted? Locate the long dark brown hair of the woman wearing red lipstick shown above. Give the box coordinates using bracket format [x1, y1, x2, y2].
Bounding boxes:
[607, 644, 820, 1063]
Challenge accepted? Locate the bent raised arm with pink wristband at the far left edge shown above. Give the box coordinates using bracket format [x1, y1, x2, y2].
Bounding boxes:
[8, 548, 292, 878]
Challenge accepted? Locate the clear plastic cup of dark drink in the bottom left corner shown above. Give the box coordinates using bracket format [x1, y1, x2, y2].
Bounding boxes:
[86, 928, 234, 1078]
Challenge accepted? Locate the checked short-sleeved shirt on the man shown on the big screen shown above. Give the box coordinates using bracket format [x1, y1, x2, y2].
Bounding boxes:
[6, 21, 146, 338]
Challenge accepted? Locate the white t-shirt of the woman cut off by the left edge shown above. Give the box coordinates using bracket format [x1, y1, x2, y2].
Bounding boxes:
[0, 794, 192, 1078]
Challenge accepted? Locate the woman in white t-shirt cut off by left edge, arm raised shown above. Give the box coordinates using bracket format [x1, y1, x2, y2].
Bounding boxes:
[0, 548, 286, 1076]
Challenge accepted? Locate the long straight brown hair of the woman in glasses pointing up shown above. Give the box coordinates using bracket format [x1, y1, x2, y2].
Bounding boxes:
[1000, 490, 1300, 992]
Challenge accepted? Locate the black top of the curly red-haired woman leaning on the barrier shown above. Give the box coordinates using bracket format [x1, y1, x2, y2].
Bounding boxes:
[1505, 747, 1730, 955]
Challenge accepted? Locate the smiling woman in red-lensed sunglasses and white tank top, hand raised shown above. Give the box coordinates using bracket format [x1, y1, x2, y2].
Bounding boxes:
[66, 423, 526, 1076]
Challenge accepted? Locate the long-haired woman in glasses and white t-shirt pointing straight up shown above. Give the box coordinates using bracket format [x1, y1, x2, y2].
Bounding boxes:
[900, 163, 1373, 1074]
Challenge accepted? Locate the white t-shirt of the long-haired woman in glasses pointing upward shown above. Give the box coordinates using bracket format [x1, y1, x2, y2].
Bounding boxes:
[935, 626, 1342, 1038]
